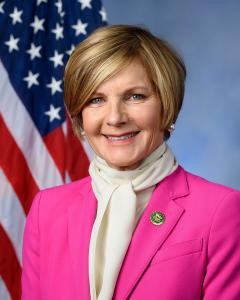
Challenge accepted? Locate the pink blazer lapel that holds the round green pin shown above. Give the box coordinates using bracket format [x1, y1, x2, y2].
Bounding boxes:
[114, 167, 189, 300]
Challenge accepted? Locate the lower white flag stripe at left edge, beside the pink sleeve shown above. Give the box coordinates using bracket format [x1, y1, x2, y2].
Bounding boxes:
[0, 169, 26, 264]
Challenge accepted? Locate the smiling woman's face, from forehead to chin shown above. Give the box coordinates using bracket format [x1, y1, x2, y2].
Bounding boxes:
[82, 59, 163, 170]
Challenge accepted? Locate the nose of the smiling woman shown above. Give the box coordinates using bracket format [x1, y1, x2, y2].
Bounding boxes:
[106, 101, 128, 127]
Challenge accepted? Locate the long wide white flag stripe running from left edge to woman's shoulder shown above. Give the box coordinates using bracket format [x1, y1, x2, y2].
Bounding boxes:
[0, 61, 62, 189]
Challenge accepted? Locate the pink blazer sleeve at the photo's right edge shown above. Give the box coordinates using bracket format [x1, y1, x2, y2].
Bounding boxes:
[203, 191, 240, 300]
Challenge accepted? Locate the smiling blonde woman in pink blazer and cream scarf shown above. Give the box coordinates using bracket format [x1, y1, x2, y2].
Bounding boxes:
[22, 25, 240, 300]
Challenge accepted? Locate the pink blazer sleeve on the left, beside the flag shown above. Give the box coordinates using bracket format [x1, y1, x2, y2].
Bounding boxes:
[22, 193, 41, 300]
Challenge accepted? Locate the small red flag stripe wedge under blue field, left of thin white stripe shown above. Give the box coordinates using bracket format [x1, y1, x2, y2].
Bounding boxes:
[43, 127, 66, 181]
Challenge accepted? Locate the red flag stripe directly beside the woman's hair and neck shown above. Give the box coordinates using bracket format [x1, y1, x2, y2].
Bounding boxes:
[66, 119, 89, 180]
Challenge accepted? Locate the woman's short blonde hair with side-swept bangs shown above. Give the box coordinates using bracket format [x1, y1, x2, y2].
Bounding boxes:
[64, 25, 186, 138]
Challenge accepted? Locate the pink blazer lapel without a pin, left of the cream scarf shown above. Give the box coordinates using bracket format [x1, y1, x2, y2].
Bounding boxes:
[68, 185, 97, 300]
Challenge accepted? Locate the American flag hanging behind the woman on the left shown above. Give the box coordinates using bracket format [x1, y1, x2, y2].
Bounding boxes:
[0, 0, 106, 300]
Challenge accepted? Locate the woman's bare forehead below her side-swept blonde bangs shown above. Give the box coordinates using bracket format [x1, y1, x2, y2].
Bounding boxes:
[96, 59, 151, 92]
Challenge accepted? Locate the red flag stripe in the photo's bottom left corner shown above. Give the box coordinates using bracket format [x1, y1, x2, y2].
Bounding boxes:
[0, 225, 21, 300]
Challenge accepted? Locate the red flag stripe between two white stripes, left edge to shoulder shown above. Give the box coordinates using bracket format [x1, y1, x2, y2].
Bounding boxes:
[0, 115, 39, 214]
